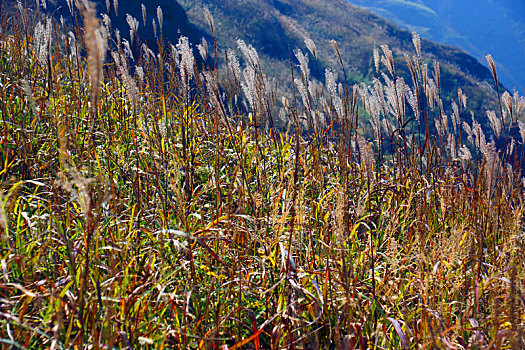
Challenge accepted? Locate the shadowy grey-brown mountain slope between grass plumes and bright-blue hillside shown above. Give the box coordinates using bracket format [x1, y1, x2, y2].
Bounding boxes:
[180, 0, 495, 115]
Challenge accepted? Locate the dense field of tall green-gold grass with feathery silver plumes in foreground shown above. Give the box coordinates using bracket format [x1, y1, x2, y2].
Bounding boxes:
[0, 3, 525, 349]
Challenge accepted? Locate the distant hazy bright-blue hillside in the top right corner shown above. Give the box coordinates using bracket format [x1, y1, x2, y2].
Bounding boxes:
[349, 0, 525, 91]
